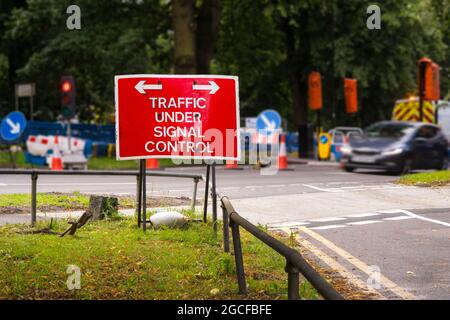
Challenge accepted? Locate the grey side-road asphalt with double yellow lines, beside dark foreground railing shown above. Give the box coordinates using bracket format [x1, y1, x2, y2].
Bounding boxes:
[283, 208, 450, 300]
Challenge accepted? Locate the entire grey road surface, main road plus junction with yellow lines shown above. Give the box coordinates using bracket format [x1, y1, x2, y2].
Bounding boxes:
[0, 162, 450, 299]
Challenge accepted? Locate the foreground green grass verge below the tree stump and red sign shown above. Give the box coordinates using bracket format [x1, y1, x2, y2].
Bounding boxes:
[0, 219, 317, 299]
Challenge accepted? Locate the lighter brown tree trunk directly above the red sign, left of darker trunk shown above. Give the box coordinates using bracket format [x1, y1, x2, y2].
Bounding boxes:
[172, 0, 196, 74]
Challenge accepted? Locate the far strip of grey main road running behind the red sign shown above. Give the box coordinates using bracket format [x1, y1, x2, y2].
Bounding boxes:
[0, 165, 397, 199]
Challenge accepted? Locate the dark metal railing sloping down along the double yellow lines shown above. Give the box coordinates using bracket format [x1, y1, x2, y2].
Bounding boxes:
[221, 197, 344, 300]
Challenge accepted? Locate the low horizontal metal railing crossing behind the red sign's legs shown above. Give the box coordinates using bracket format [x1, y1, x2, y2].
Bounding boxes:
[0, 169, 203, 225]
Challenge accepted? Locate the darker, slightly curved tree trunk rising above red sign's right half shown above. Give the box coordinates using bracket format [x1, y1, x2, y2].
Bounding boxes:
[196, 0, 220, 74]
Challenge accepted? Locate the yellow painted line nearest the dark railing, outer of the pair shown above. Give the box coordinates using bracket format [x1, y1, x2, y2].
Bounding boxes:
[281, 228, 387, 300]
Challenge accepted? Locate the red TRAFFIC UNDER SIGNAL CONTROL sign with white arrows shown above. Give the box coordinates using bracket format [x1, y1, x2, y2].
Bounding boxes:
[115, 75, 240, 160]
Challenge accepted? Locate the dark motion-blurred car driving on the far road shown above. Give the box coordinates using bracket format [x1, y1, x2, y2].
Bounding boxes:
[341, 121, 449, 174]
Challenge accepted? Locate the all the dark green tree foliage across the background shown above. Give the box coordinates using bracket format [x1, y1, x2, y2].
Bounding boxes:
[0, 0, 450, 129]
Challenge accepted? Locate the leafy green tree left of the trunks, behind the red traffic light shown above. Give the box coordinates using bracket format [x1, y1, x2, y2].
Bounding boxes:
[4, 0, 172, 122]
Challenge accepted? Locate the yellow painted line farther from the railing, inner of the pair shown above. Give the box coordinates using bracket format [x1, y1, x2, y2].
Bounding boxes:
[298, 227, 417, 300]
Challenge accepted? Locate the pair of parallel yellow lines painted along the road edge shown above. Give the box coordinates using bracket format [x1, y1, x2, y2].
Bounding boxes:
[281, 227, 417, 300]
